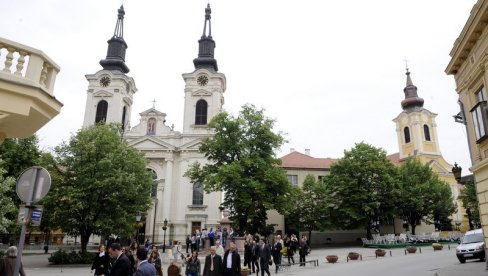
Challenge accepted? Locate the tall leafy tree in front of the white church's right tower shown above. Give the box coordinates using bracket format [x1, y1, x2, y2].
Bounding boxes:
[185, 105, 291, 234]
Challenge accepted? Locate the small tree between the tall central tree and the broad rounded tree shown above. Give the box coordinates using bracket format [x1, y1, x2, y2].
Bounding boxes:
[286, 174, 331, 242]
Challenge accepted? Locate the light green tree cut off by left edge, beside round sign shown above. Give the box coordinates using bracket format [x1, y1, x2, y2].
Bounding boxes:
[0, 163, 18, 234]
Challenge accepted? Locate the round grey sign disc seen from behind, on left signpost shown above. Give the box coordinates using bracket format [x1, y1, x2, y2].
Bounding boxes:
[16, 166, 51, 204]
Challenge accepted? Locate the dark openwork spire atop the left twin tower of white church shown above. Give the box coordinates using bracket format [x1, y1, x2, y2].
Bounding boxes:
[100, 5, 129, 73]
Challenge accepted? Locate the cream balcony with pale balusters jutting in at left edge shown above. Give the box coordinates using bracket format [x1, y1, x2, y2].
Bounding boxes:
[0, 37, 63, 143]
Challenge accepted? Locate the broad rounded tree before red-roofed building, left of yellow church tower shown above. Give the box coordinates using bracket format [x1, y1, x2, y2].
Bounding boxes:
[325, 143, 399, 238]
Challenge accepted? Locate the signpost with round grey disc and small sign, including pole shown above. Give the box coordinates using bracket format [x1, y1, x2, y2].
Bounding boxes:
[14, 166, 51, 276]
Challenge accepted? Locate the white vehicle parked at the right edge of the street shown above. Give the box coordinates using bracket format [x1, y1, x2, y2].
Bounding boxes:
[456, 229, 485, 263]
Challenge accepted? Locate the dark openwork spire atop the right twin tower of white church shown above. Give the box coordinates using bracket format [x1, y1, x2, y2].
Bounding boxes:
[193, 3, 218, 71]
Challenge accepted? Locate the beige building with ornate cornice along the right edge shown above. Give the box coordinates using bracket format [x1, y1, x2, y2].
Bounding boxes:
[445, 0, 488, 258]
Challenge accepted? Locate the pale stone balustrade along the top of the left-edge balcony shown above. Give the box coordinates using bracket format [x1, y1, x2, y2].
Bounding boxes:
[0, 37, 59, 95]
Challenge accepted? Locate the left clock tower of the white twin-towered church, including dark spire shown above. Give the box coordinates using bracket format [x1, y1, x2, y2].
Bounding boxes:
[83, 6, 137, 131]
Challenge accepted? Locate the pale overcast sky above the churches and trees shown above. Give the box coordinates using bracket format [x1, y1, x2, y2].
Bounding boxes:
[0, 0, 476, 174]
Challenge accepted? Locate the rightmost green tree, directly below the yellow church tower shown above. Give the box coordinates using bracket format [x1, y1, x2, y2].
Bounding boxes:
[398, 158, 456, 234]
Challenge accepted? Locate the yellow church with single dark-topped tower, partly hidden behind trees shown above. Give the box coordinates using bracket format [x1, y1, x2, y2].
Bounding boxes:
[393, 68, 469, 232]
